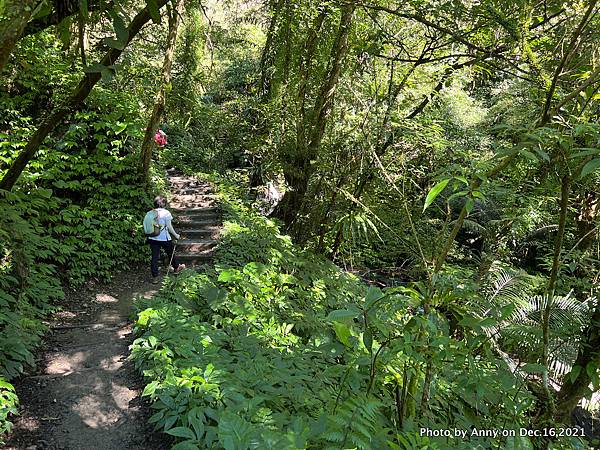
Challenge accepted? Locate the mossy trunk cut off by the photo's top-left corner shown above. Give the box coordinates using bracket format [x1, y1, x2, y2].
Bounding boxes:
[0, 0, 39, 72]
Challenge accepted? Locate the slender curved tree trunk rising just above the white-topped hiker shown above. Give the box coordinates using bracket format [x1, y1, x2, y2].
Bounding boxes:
[140, 0, 185, 181]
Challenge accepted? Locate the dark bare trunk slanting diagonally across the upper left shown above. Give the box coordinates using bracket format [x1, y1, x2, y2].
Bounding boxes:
[0, 0, 168, 191]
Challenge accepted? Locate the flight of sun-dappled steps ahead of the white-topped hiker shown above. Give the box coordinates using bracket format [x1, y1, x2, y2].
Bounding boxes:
[167, 170, 221, 267]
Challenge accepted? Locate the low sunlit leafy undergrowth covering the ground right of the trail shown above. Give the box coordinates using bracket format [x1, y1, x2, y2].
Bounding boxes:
[131, 176, 564, 450]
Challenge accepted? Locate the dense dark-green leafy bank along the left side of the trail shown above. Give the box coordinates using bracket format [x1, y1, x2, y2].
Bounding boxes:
[0, 89, 164, 435]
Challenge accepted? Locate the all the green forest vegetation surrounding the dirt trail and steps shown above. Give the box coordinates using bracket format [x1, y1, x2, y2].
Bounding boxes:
[0, 0, 600, 449]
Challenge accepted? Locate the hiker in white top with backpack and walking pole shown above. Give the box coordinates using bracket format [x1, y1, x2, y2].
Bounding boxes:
[144, 196, 185, 284]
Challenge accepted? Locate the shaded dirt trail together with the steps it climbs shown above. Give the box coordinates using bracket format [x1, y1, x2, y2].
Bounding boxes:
[6, 174, 220, 450]
